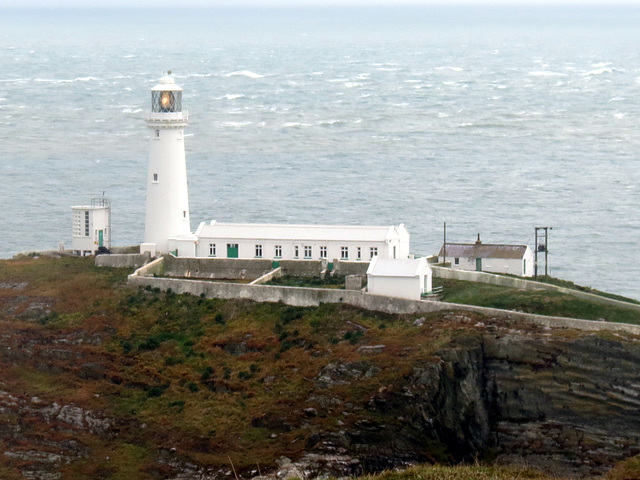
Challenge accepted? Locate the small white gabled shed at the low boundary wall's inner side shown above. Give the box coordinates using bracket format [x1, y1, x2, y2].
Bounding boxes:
[367, 257, 433, 300]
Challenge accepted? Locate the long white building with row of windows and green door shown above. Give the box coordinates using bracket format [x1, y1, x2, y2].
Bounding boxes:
[195, 220, 409, 262]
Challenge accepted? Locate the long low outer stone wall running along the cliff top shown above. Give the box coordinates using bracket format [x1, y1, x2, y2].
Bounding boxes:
[129, 268, 640, 335]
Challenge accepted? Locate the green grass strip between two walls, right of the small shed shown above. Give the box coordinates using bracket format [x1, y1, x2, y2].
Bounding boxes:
[434, 278, 640, 325]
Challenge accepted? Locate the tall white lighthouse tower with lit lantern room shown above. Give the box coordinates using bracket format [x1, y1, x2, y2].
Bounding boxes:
[141, 71, 193, 255]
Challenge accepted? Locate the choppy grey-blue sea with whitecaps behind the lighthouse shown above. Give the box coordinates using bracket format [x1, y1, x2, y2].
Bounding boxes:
[0, 2, 640, 299]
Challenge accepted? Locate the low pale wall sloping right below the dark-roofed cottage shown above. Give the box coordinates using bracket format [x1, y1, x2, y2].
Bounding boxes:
[431, 266, 640, 311]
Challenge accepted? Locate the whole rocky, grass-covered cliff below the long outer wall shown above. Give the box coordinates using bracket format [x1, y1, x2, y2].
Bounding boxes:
[0, 260, 640, 480]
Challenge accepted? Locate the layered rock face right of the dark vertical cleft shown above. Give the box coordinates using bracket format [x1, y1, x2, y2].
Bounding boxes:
[486, 335, 640, 475]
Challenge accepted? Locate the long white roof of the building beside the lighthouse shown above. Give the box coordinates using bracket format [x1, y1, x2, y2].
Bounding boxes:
[196, 221, 398, 242]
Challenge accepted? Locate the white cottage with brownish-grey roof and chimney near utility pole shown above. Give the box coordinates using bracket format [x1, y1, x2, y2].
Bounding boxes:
[438, 235, 534, 277]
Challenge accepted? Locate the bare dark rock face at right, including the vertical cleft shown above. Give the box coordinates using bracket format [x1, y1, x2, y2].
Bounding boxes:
[309, 332, 640, 476]
